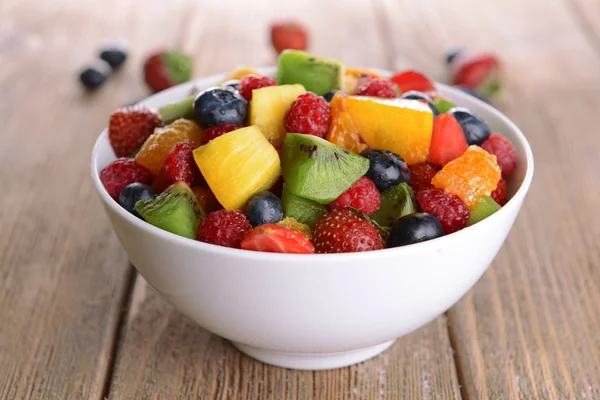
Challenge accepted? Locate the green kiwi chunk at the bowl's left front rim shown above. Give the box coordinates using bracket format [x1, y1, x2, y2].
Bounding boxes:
[133, 182, 205, 239]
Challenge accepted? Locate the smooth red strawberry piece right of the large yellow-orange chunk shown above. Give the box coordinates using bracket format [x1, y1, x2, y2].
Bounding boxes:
[427, 114, 468, 167]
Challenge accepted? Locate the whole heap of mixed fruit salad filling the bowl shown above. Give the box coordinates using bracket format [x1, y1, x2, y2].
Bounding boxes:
[100, 50, 518, 254]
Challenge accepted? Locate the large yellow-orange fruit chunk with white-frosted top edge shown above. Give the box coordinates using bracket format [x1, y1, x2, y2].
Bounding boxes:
[342, 96, 433, 165]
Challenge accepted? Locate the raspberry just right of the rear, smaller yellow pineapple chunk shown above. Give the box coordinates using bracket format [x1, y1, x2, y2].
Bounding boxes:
[284, 92, 331, 137]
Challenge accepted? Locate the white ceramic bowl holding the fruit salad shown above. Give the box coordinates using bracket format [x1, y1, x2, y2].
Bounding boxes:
[92, 69, 533, 370]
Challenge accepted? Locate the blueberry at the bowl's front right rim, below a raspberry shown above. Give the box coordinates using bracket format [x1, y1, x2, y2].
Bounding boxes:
[387, 213, 444, 247]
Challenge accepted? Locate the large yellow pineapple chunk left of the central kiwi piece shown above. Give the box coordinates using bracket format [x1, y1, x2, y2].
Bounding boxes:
[194, 126, 281, 210]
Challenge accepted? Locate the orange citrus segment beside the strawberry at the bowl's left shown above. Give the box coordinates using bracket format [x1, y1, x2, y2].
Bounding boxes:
[135, 119, 203, 175]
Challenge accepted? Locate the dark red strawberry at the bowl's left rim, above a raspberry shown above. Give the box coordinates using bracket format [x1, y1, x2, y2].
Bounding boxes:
[108, 106, 162, 157]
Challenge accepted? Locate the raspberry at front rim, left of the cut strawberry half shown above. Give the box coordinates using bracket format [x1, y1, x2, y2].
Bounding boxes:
[198, 210, 252, 249]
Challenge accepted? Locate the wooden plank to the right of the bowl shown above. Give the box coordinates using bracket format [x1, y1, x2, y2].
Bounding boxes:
[384, 0, 600, 399]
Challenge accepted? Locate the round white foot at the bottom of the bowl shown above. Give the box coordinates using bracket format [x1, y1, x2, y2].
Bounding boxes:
[232, 340, 396, 370]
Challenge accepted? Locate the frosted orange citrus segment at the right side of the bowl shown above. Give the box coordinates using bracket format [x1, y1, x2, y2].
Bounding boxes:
[431, 146, 500, 210]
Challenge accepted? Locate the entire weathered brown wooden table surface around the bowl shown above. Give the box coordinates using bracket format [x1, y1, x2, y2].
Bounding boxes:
[0, 0, 600, 400]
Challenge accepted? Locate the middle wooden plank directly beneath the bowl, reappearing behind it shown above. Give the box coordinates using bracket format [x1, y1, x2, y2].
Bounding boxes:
[109, 0, 460, 399]
